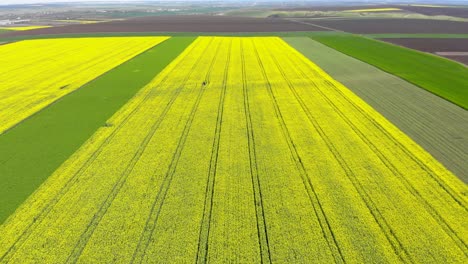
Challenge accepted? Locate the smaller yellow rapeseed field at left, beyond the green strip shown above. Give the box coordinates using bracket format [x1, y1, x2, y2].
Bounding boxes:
[0, 37, 167, 134]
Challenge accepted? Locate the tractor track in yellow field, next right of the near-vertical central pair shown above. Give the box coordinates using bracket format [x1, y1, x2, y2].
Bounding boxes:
[252, 39, 345, 263]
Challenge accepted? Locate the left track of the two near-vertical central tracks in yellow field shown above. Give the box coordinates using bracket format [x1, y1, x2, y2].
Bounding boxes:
[197, 41, 232, 263]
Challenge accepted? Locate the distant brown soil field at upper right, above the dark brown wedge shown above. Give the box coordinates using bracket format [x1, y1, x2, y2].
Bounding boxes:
[303, 19, 468, 34]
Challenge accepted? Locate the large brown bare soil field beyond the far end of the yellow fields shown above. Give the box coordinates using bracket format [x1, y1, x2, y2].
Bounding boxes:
[2, 16, 324, 37]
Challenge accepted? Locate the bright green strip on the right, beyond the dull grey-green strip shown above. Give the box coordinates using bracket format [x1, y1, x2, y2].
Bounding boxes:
[312, 35, 468, 109]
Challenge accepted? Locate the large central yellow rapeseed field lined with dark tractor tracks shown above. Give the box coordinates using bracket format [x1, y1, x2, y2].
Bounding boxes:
[0, 37, 468, 263]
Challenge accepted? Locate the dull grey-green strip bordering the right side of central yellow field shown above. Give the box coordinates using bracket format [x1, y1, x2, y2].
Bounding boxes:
[284, 37, 468, 182]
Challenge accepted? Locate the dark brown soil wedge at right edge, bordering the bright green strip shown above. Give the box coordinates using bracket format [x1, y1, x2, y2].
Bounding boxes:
[380, 38, 468, 65]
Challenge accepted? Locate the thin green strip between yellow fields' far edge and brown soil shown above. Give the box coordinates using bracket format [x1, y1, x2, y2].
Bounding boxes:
[0, 31, 348, 41]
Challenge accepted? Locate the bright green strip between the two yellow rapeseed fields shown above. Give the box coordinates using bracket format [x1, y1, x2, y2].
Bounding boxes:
[0, 37, 194, 223]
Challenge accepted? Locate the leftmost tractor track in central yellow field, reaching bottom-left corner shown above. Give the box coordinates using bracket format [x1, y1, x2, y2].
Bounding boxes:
[0, 39, 199, 262]
